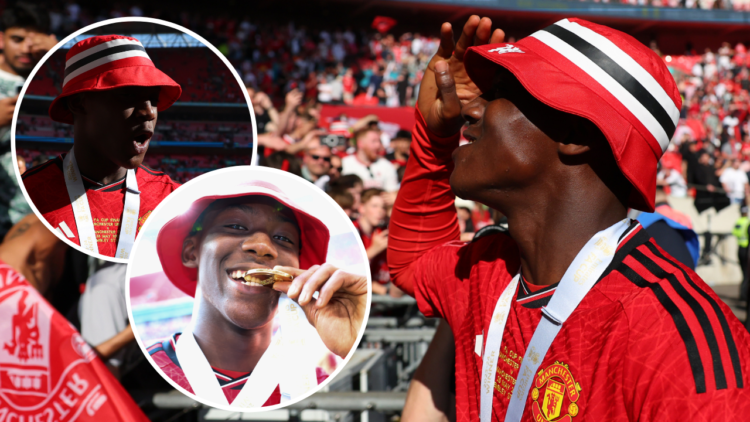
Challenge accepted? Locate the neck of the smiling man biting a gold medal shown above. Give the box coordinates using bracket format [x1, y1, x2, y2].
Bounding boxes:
[193, 301, 273, 372]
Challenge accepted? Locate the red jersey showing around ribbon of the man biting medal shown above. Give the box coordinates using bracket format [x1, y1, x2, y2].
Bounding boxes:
[147, 333, 328, 406]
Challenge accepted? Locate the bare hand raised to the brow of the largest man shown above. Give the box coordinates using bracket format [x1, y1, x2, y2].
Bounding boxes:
[417, 15, 505, 137]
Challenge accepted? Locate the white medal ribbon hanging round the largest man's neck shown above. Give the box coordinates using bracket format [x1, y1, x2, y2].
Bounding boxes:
[480, 219, 630, 422]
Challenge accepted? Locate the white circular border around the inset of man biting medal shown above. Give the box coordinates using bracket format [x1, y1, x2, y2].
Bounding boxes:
[125, 165, 372, 413]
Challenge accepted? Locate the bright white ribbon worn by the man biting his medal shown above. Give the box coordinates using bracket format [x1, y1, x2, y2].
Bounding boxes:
[175, 295, 318, 408]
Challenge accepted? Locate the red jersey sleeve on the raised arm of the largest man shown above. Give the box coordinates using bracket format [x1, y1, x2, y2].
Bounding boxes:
[388, 108, 460, 295]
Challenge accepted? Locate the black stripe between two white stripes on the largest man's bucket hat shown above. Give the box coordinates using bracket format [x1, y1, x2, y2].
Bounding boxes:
[542, 25, 675, 139]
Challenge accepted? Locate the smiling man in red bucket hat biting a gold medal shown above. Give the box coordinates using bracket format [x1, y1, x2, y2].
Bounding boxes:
[148, 182, 367, 408]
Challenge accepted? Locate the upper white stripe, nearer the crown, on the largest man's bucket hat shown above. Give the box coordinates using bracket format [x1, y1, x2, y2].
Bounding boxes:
[555, 19, 680, 126]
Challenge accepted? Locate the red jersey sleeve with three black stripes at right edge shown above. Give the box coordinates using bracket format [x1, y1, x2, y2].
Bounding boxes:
[619, 266, 750, 422]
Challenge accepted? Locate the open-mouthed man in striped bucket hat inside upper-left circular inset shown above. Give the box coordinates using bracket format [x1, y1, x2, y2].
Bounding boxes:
[23, 35, 182, 259]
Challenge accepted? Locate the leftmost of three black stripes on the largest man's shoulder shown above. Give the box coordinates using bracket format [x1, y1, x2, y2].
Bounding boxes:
[617, 262, 706, 394]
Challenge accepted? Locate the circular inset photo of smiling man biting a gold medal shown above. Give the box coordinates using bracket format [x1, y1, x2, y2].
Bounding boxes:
[127, 166, 371, 410]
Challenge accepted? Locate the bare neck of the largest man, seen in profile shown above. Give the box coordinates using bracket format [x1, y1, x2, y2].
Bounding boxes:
[499, 175, 627, 286]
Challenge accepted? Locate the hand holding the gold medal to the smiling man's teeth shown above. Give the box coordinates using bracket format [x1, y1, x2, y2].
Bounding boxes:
[273, 264, 367, 358]
